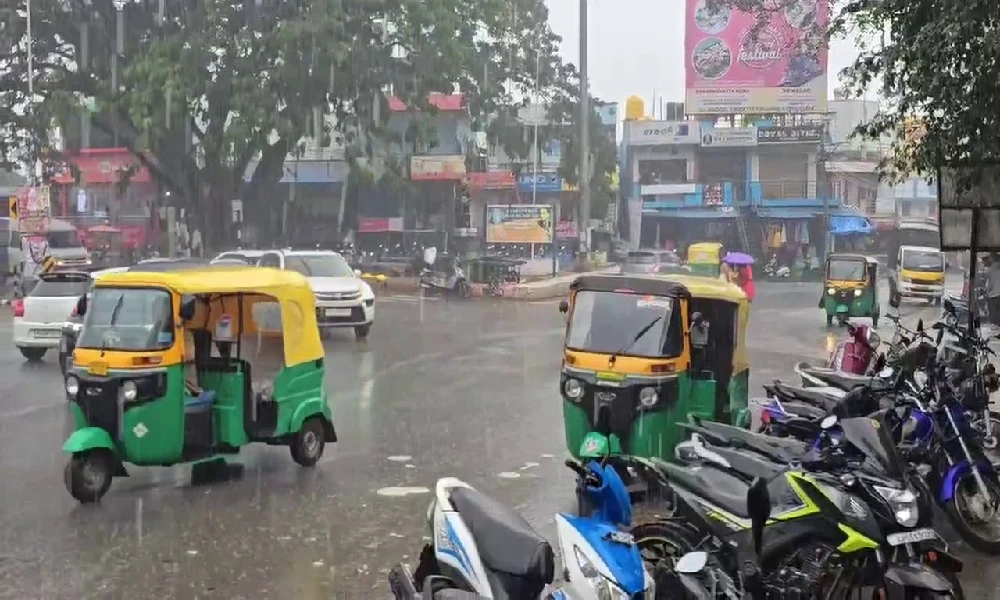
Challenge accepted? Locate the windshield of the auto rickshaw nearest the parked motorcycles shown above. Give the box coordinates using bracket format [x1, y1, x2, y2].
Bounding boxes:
[566, 290, 681, 358]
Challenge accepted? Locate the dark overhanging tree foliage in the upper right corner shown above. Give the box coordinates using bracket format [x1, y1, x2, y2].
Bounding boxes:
[710, 0, 1000, 184]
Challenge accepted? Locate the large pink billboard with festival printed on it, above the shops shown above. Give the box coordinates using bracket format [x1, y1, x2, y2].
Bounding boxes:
[684, 0, 829, 114]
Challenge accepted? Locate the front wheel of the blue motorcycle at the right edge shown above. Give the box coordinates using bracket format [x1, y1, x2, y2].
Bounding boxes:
[944, 473, 1000, 556]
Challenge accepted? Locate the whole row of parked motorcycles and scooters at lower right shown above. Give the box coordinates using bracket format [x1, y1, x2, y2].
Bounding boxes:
[389, 302, 1000, 600]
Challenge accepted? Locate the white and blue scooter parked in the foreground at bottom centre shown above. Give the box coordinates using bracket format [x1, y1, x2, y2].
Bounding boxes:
[389, 461, 654, 600]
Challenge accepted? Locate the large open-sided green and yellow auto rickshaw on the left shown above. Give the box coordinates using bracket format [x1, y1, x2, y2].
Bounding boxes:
[63, 266, 337, 502]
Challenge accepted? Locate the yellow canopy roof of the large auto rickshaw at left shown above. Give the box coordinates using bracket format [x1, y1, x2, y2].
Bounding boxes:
[94, 265, 324, 366]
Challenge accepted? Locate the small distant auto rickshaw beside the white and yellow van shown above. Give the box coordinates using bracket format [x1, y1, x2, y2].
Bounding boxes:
[819, 254, 881, 327]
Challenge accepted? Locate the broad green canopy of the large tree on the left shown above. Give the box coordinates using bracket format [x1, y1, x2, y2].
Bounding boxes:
[0, 0, 563, 243]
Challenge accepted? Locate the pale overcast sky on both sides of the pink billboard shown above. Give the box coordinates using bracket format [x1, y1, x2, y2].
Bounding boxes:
[545, 0, 855, 114]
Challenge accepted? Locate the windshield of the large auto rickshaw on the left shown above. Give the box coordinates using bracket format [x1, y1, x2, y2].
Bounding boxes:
[77, 287, 174, 352]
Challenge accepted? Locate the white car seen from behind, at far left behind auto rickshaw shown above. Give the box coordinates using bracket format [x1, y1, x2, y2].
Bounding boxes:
[11, 271, 91, 360]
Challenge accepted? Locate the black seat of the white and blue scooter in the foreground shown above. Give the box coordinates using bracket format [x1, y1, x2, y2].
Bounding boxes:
[450, 487, 555, 589]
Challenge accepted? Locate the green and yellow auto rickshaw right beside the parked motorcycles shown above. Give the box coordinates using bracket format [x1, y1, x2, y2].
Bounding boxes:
[559, 275, 750, 459]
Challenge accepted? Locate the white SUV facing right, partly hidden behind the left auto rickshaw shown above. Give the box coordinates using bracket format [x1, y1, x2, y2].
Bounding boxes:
[257, 250, 375, 340]
